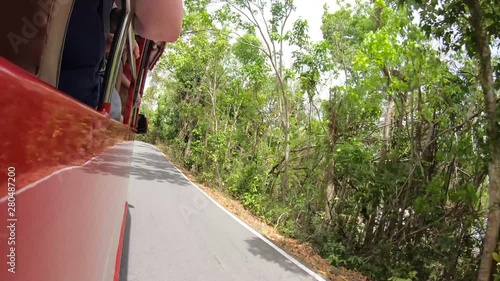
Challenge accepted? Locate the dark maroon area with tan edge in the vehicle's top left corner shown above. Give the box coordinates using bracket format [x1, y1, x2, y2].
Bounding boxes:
[0, 0, 75, 87]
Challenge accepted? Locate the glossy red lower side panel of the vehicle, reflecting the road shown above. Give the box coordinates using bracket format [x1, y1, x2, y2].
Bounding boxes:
[0, 58, 134, 281]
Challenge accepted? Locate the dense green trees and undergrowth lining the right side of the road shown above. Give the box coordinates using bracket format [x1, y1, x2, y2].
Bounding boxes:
[138, 0, 500, 281]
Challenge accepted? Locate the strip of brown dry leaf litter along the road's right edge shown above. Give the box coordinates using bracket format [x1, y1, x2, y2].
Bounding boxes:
[157, 146, 370, 281]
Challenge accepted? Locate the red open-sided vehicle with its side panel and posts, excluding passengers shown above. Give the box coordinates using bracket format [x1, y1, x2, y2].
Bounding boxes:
[0, 3, 165, 281]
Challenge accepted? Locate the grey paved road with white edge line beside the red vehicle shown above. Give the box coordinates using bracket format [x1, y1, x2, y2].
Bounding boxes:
[120, 142, 323, 281]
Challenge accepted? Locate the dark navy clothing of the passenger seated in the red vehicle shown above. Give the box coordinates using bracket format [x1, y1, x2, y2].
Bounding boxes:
[59, 0, 112, 108]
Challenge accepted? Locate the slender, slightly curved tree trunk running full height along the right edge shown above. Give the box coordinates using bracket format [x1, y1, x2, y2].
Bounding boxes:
[465, 0, 500, 281]
